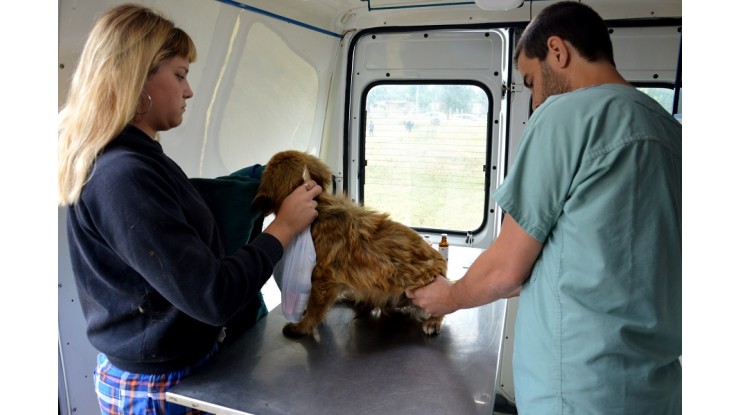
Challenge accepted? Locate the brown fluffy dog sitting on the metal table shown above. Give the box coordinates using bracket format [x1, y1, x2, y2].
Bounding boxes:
[254, 151, 447, 337]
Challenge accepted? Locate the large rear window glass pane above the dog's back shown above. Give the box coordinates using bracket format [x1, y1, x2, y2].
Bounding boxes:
[362, 83, 491, 232]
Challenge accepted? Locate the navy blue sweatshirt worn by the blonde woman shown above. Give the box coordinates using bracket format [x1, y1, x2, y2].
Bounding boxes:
[67, 126, 283, 373]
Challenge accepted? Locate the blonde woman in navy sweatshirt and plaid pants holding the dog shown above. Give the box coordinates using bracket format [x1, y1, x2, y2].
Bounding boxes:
[59, 4, 322, 414]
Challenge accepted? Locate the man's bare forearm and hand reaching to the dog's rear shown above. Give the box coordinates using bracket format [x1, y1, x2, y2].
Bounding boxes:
[406, 215, 542, 316]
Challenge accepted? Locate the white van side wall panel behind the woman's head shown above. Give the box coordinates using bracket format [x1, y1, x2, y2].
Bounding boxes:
[59, 0, 340, 177]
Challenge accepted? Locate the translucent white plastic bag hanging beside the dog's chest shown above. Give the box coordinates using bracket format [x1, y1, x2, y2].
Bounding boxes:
[275, 226, 316, 323]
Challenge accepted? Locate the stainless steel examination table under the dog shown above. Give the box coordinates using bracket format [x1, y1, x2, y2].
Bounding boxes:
[167, 247, 506, 415]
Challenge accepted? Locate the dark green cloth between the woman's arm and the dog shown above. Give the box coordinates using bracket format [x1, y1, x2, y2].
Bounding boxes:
[190, 164, 268, 344]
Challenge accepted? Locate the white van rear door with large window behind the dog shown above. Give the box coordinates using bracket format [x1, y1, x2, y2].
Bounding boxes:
[345, 28, 510, 246]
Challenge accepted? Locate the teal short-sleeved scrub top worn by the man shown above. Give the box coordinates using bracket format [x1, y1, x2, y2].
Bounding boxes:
[494, 84, 681, 415]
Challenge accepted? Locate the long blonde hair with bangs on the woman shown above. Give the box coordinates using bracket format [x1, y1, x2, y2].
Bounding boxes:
[58, 4, 196, 206]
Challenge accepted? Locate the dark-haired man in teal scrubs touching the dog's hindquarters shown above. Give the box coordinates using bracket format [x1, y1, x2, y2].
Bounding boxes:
[407, 1, 681, 414]
